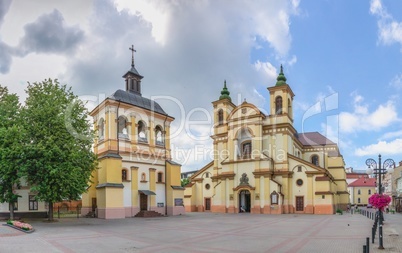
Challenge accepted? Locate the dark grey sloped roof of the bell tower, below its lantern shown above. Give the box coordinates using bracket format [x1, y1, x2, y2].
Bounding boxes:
[108, 90, 168, 116]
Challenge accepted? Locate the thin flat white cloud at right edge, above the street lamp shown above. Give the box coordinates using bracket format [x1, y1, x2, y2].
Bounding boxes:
[355, 138, 402, 156]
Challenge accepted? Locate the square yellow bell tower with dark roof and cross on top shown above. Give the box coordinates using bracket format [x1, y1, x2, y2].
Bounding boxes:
[81, 47, 185, 219]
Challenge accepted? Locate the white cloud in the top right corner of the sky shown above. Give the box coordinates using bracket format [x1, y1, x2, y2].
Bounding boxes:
[370, 0, 402, 46]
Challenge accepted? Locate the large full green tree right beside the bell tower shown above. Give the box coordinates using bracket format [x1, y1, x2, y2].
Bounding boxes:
[23, 79, 96, 221]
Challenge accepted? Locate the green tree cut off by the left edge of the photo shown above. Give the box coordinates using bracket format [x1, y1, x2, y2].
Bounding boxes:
[0, 85, 24, 220]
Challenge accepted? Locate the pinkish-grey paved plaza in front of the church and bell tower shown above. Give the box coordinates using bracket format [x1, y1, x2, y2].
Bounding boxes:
[0, 213, 402, 253]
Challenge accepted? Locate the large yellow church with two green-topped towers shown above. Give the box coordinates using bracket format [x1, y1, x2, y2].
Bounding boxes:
[184, 66, 349, 214]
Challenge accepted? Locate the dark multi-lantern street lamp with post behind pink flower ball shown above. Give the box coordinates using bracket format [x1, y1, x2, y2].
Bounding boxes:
[366, 155, 395, 249]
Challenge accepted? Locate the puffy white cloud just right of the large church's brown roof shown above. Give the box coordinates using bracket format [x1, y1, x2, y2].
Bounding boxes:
[339, 94, 400, 133]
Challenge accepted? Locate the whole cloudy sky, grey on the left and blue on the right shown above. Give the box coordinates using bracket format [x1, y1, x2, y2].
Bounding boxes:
[0, 0, 402, 171]
